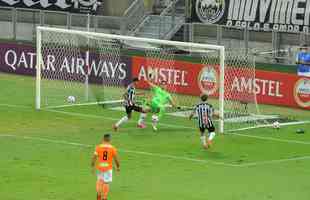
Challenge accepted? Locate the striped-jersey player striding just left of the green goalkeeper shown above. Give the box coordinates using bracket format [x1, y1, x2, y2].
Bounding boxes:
[113, 78, 146, 131]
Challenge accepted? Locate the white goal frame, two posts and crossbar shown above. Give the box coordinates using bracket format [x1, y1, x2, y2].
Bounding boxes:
[35, 26, 225, 133]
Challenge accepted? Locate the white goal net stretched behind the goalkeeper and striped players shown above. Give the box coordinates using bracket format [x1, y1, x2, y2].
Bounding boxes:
[36, 27, 263, 132]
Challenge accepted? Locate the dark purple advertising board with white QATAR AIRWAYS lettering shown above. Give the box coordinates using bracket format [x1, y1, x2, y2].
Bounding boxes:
[0, 44, 131, 85]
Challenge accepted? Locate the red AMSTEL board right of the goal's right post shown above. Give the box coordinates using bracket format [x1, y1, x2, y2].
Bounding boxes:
[231, 70, 310, 110]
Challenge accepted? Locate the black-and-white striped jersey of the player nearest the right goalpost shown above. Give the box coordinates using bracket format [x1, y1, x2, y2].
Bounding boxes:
[194, 102, 214, 128]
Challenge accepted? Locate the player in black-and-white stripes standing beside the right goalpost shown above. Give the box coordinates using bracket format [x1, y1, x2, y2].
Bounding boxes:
[189, 94, 219, 149]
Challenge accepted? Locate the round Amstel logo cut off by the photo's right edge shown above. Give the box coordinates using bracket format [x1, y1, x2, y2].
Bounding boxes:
[294, 78, 310, 108]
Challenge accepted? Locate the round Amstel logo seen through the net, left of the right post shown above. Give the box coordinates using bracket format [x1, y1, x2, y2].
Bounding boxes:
[198, 65, 219, 95]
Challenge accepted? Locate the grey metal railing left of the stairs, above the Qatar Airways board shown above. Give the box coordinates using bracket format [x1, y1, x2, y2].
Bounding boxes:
[0, 6, 137, 42]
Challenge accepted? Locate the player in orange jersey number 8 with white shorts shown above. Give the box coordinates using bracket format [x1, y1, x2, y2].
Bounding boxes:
[91, 134, 120, 200]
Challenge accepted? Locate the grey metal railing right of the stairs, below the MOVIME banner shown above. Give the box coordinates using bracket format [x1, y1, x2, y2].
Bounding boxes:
[173, 23, 310, 65]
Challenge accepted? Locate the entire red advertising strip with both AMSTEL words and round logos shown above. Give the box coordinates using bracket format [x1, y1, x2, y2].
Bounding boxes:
[132, 57, 310, 110]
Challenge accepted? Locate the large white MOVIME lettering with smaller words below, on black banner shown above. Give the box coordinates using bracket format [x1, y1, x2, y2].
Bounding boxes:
[226, 0, 310, 32]
